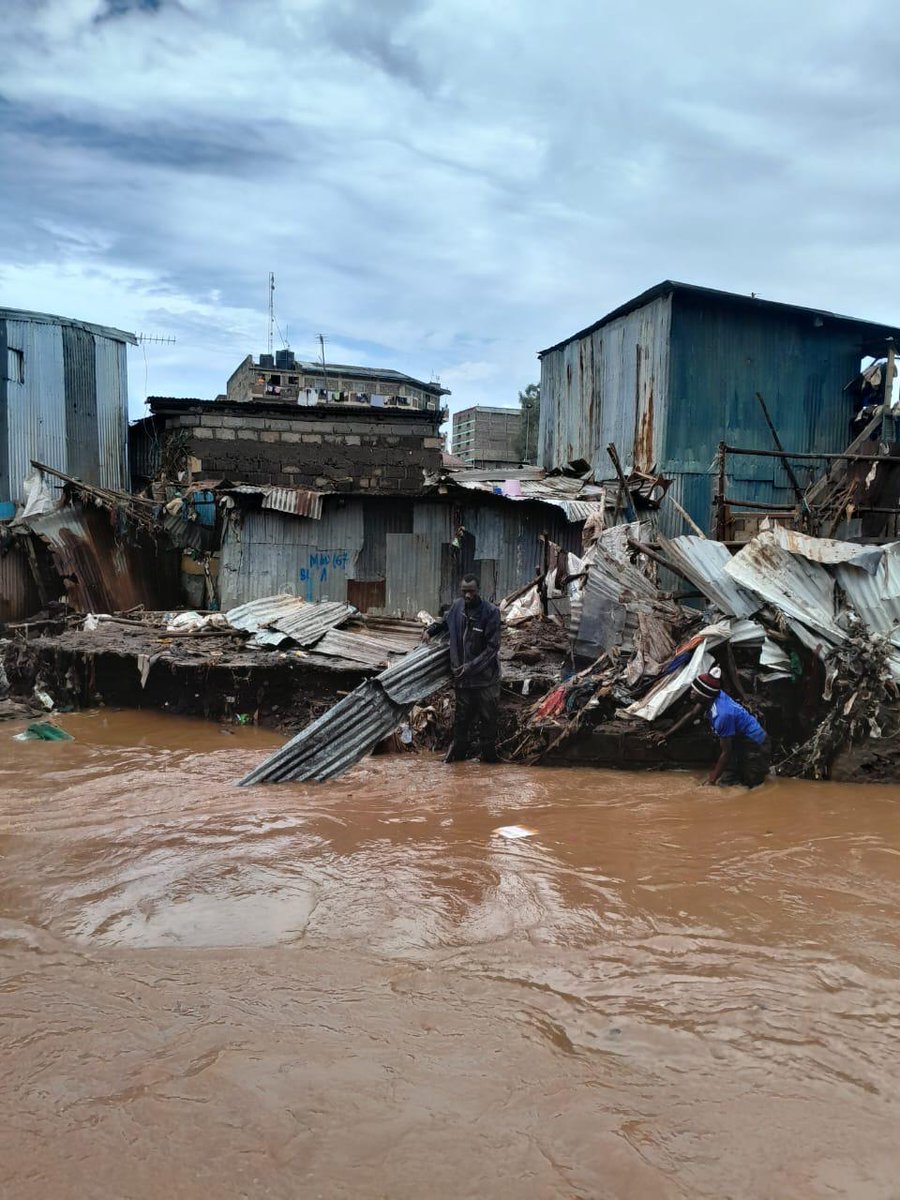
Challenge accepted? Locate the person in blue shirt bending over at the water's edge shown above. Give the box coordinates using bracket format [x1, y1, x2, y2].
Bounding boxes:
[662, 667, 770, 787]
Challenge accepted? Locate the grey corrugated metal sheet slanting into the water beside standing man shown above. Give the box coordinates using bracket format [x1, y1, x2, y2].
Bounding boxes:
[240, 643, 450, 787]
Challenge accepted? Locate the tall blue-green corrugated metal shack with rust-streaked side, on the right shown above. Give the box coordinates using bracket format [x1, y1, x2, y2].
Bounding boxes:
[539, 280, 900, 533]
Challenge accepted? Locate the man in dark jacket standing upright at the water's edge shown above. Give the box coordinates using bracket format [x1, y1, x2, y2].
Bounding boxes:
[425, 575, 500, 762]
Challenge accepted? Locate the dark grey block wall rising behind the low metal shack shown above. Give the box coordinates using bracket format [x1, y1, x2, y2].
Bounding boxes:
[153, 403, 443, 492]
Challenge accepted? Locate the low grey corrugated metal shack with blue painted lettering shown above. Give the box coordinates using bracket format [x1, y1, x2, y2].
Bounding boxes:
[218, 488, 584, 616]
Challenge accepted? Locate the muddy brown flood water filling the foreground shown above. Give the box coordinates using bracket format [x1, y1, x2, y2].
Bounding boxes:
[0, 713, 900, 1200]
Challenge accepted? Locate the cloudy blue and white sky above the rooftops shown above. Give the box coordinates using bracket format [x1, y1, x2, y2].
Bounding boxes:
[0, 0, 900, 415]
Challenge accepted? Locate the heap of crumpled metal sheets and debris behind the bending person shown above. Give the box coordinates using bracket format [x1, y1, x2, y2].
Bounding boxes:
[503, 523, 900, 779]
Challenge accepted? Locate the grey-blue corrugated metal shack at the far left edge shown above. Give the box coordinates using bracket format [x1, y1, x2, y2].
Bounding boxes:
[0, 308, 137, 516]
